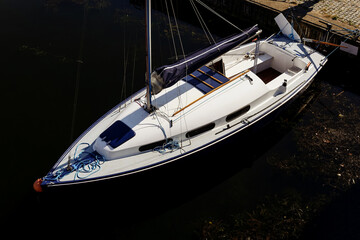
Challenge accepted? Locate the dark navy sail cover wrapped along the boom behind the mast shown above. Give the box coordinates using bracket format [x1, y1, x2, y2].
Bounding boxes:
[151, 25, 259, 94]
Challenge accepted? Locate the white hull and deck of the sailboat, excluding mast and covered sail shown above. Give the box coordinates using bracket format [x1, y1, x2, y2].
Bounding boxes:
[42, 34, 327, 187]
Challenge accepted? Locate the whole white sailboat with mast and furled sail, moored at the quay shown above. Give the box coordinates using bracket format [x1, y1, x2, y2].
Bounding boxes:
[34, 1, 327, 191]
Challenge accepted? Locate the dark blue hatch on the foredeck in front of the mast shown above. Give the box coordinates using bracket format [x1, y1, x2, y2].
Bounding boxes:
[100, 121, 135, 148]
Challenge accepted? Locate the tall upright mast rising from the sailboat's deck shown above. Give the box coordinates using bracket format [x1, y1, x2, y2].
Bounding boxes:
[146, 0, 152, 112]
